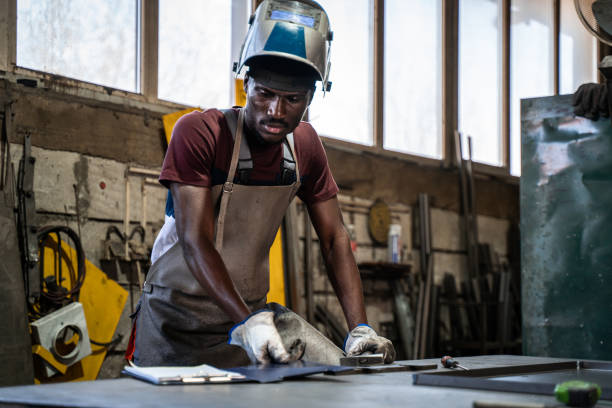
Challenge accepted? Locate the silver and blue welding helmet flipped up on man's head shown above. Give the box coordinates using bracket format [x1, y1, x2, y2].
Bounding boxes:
[234, 0, 333, 92]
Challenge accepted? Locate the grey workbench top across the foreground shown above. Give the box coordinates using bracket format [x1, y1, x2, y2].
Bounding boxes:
[0, 355, 604, 408]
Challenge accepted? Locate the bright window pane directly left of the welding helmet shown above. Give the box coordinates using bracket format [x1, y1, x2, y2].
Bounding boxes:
[158, 0, 239, 108]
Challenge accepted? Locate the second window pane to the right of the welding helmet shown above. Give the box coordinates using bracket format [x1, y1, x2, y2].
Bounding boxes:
[383, 0, 442, 158]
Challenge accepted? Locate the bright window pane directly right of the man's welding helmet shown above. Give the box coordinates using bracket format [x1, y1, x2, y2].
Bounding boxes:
[308, 0, 373, 145]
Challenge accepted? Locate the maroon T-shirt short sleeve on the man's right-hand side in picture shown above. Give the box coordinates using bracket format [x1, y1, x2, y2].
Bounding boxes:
[296, 123, 338, 205]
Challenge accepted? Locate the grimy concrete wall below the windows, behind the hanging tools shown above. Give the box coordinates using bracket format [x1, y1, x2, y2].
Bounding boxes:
[0, 78, 518, 377]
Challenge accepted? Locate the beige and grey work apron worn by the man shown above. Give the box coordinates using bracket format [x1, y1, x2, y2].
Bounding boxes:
[134, 110, 300, 367]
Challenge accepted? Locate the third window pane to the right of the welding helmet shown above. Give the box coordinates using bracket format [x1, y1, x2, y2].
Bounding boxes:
[459, 0, 503, 166]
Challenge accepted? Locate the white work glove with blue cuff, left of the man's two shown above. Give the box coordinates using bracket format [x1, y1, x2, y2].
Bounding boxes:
[228, 309, 305, 364]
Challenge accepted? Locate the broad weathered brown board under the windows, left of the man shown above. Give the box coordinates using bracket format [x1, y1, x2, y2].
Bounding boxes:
[10, 87, 164, 167]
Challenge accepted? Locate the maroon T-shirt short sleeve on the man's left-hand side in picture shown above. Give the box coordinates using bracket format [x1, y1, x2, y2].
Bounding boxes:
[159, 111, 219, 187]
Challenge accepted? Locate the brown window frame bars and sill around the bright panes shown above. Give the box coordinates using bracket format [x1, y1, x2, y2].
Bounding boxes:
[0, 0, 602, 183]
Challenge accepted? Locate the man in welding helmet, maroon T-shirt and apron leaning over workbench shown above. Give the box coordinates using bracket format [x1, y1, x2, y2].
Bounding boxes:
[128, 0, 395, 367]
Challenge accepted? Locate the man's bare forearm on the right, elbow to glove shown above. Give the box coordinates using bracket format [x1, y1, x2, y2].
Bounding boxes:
[321, 230, 368, 330]
